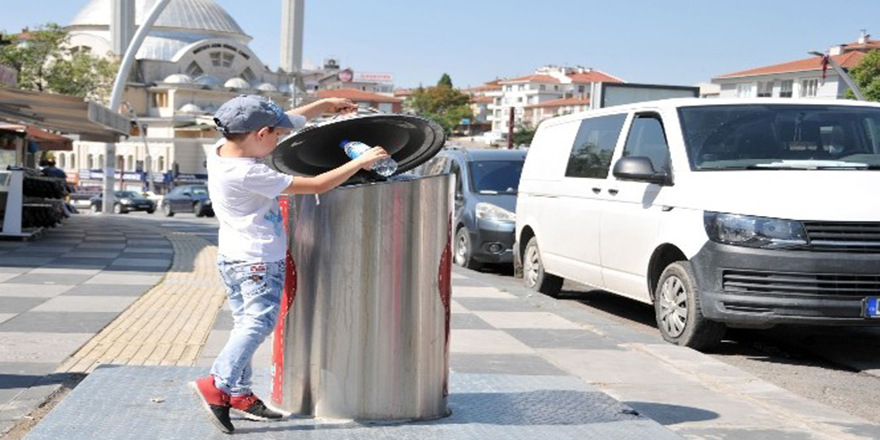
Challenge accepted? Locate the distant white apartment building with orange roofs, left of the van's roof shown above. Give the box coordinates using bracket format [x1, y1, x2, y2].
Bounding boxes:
[487, 66, 623, 133]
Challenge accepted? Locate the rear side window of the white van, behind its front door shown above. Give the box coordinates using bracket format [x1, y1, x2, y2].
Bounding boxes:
[565, 114, 626, 179]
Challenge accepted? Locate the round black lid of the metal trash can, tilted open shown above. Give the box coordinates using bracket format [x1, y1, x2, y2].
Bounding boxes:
[267, 114, 446, 183]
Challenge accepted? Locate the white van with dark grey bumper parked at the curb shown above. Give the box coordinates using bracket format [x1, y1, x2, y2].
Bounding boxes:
[515, 98, 880, 349]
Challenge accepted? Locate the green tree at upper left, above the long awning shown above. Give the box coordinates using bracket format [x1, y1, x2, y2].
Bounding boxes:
[0, 23, 118, 100]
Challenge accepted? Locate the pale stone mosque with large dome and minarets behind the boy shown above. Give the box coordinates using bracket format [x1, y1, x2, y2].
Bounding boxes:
[57, 0, 398, 192]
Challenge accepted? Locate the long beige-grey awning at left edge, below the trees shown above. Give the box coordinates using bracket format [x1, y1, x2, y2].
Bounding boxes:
[0, 87, 131, 142]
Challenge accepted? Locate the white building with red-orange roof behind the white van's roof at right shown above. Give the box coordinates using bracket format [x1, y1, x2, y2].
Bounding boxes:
[712, 33, 880, 99]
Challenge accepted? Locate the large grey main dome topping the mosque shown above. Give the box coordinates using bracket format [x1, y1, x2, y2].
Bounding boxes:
[66, 0, 251, 61]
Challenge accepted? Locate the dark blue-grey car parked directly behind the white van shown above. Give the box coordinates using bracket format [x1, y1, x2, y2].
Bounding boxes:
[419, 149, 526, 269]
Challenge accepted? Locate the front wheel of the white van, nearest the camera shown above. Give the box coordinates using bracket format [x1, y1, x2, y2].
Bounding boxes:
[654, 261, 726, 350]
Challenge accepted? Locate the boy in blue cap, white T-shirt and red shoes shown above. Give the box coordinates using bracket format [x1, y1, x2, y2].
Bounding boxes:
[190, 95, 388, 434]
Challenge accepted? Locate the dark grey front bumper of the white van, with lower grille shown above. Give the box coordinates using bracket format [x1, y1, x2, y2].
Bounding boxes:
[691, 242, 880, 327]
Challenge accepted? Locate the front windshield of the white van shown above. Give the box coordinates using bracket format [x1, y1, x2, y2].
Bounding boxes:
[679, 104, 880, 171]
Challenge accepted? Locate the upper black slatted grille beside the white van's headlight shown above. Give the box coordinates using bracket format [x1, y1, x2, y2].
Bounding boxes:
[804, 222, 880, 253]
